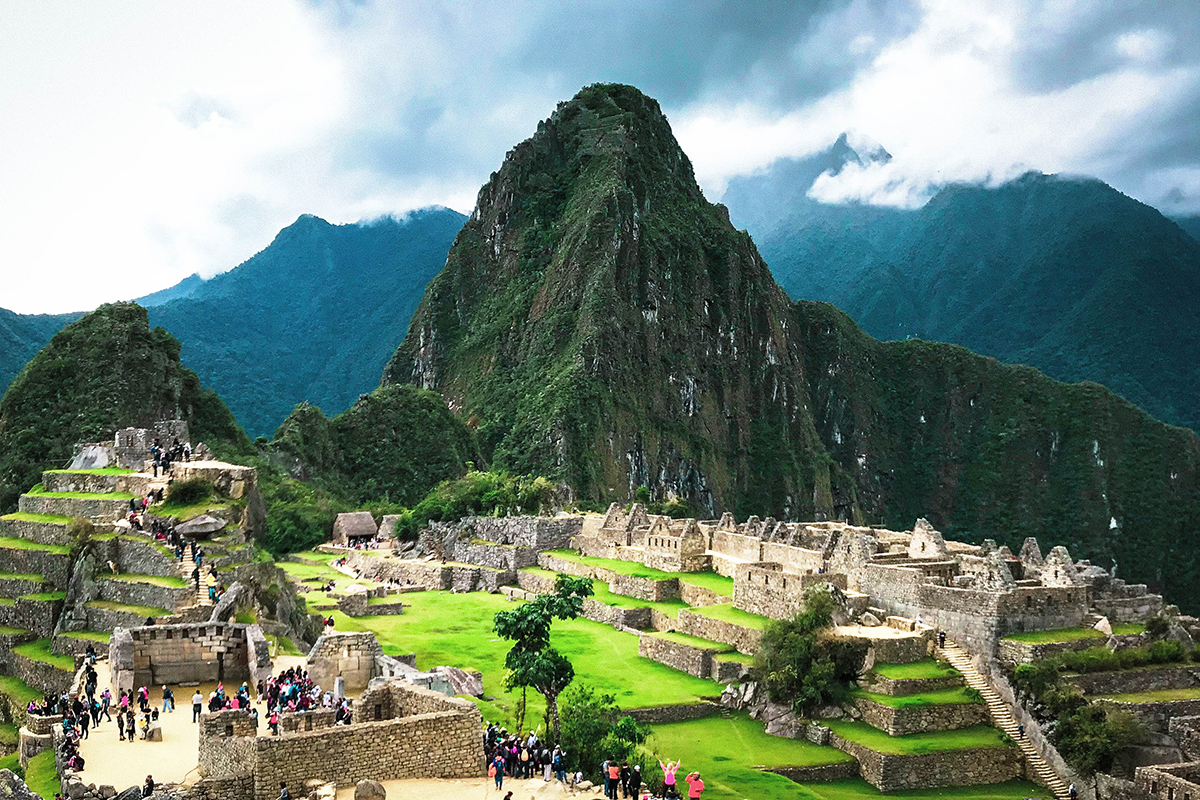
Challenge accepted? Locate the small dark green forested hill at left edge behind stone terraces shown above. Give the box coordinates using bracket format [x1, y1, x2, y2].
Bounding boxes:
[0, 303, 250, 511]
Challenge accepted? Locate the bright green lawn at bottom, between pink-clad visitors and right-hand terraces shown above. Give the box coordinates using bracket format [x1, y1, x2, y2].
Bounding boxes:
[648, 714, 852, 800]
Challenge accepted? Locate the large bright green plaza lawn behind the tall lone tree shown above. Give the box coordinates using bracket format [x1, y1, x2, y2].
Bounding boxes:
[332, 591, 718, 722]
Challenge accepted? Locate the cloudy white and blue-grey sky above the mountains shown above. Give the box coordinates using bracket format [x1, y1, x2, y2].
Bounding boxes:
[0, 0, 1200, 313]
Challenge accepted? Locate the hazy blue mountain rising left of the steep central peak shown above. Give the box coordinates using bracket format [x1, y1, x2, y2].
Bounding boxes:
[150, 207, 464, 437]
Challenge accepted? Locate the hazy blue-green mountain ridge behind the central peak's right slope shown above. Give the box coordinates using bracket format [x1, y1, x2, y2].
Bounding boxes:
[725, 145, 1200, 429]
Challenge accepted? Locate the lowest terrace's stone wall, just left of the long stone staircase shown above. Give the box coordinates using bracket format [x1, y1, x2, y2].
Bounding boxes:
[829, 733, 1022, 792]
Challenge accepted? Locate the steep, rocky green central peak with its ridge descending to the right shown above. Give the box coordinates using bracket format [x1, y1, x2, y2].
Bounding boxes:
[384, 85, 1200, 606]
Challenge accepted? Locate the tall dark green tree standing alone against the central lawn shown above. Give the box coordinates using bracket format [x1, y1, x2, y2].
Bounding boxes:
[493, 575, 593, 740]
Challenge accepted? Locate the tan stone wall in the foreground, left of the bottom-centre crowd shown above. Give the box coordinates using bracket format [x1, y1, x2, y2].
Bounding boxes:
[253, 681, 484, 800]
